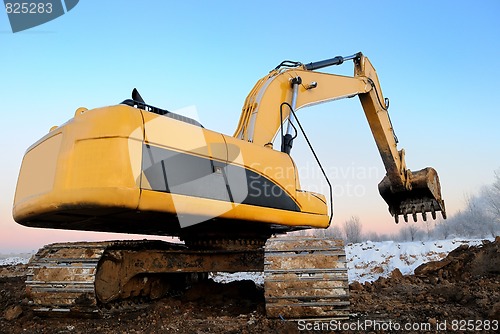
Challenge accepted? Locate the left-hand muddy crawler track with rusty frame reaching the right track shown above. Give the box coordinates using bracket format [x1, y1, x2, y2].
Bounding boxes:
[26, 241, 264, 316]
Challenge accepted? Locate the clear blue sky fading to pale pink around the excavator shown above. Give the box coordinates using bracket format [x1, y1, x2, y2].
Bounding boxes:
[0, 0, 500, 251]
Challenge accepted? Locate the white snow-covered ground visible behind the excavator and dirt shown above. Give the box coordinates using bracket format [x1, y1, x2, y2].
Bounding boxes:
[0, 239, 490, 284]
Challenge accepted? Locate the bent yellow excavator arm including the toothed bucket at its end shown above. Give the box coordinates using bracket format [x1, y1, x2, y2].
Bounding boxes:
[234, 53, 446, 222]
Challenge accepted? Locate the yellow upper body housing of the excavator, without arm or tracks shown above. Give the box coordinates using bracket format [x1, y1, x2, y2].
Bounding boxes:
[13, 105, 329, 235]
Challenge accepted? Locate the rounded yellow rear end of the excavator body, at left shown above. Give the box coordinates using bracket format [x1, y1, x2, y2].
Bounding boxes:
[13, 106, 142, 226]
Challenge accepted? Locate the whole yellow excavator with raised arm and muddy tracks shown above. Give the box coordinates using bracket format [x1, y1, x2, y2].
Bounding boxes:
[13, 53, 446, 319]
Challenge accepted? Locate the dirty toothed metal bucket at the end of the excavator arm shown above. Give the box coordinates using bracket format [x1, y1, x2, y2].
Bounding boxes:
[378, 167, 446, 223]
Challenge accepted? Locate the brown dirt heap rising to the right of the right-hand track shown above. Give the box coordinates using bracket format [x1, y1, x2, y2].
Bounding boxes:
[350, 237, 500, 325]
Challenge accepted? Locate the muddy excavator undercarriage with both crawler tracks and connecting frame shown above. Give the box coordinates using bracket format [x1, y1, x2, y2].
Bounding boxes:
[26, 237, 349, 320]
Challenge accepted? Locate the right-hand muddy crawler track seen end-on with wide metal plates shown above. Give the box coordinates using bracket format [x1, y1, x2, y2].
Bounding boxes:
[264, 237, 349, 320]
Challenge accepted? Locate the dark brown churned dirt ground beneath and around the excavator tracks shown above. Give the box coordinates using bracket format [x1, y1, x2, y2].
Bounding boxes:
[0, 237, 500, 333]
